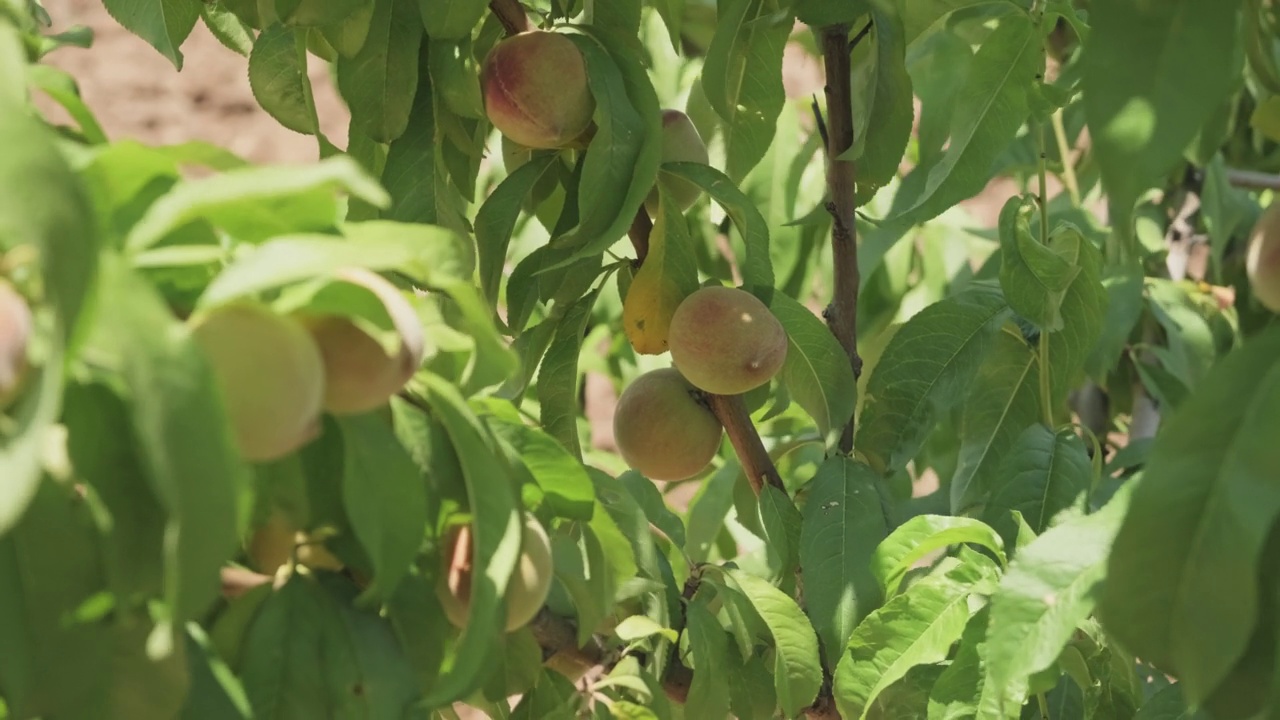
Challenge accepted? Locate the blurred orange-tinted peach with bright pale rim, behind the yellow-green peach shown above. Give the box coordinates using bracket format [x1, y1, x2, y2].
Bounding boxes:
[303, 268, 425, 415]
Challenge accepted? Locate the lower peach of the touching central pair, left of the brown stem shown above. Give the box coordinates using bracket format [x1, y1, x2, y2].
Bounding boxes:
[613, 368, 724, 482]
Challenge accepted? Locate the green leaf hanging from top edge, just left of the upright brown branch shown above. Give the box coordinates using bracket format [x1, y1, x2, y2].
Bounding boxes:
[701, 0, 792, 182]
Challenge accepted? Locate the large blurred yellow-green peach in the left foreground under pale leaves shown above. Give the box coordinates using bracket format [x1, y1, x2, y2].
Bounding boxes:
[192, 302, 324, 462]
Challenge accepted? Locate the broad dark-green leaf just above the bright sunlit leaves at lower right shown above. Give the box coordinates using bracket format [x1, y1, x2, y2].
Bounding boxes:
[984, 424, 1093, 533]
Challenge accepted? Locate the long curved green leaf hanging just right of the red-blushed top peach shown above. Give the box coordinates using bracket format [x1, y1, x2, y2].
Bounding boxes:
[552, 28, 662, 264]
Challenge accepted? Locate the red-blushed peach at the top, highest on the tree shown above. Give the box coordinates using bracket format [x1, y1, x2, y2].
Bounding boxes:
[480, 29, 595, 147]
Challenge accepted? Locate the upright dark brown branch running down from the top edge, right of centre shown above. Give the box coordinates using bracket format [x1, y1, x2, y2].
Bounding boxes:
[822, 24, 861, 452]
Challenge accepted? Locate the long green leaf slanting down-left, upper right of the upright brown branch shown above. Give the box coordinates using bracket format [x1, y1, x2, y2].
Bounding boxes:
[886, 13, 1044, 225]
